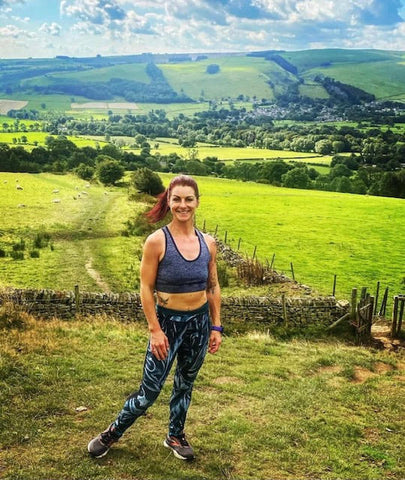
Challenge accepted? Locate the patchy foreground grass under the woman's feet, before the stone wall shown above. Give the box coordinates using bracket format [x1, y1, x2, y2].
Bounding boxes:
[0, 309, 405, 480]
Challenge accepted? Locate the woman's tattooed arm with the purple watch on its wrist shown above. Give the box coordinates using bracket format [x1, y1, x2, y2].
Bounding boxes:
[206, 235, 222, 353]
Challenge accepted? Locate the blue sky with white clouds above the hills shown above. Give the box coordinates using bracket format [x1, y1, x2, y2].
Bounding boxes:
[0, 0, 405, 58]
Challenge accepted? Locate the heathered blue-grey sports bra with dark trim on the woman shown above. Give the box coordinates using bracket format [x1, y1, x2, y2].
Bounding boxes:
[155, 226, 211, 293]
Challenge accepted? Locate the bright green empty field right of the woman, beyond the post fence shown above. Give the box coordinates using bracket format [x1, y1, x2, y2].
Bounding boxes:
[166, 174, 405, 299]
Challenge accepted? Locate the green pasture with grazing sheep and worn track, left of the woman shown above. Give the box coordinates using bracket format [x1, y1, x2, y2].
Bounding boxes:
[0, 173, 143, 291]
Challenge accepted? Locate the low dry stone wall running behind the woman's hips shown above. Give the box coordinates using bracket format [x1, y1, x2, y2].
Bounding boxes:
[0, 288, 349, 330]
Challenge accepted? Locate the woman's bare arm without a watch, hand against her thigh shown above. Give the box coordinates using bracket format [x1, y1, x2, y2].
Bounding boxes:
[140, 231, 169, 360]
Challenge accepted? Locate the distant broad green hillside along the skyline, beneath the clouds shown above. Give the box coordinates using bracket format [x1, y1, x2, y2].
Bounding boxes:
[0, 49, 405, 115]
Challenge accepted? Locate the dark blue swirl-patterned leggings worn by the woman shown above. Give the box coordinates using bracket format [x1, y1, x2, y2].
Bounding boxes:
[113, 303, 211, 437]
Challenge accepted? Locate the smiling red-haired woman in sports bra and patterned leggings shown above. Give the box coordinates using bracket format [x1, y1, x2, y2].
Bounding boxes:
[88, 175, 222, 460]
